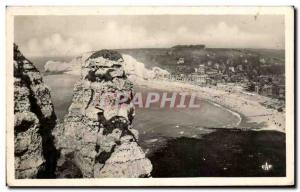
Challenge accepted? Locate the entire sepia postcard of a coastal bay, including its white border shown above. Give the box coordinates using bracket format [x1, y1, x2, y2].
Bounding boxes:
[6, 7, 295, 186]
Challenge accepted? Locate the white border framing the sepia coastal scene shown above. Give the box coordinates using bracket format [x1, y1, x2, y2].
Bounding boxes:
[6, 6, 294, 186]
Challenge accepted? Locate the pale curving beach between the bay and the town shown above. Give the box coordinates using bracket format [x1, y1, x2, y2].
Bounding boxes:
[136, 80, 285, 133]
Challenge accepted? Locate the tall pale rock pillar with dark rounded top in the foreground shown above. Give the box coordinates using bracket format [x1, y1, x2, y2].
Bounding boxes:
[53, 50, 152, 178]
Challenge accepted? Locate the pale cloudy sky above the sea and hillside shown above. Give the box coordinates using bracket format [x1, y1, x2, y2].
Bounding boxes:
[14, 15, 285, 56]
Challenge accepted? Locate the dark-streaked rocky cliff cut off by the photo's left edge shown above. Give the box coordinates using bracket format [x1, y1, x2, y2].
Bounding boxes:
[14, 45, 56, 179]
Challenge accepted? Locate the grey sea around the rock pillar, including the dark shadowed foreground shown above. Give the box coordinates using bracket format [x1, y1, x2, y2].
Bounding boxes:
[29, 57, 286, 177]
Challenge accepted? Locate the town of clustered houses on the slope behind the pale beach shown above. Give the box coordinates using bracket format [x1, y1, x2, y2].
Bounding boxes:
[155, 46, 285, 101]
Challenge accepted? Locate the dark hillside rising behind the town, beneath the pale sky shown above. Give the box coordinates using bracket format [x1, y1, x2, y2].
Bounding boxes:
[118, 46, 285, 78]
